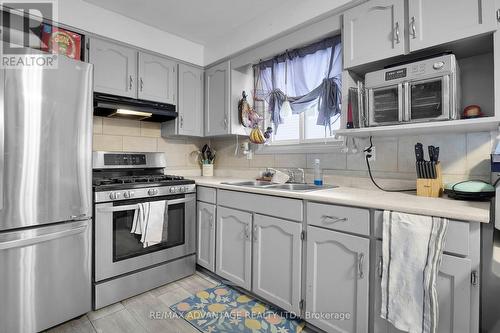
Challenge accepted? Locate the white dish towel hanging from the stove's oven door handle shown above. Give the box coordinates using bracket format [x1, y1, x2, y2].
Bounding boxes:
[130, 201, 167, 247]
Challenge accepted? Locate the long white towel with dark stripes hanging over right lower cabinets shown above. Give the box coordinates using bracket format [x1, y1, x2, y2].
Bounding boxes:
[380, 211, 448, 333]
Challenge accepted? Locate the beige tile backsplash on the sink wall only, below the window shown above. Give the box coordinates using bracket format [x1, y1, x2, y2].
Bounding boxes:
[212, 132, 497, 187]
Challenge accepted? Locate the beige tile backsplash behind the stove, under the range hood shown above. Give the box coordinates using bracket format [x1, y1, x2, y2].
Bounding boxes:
[93, 117, 204, 176]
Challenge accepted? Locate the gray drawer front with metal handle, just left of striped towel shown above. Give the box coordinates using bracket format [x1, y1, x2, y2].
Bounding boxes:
[307, 202, 370, 236]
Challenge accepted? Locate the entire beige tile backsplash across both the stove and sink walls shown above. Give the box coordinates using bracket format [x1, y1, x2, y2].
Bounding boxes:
[94, 117, 498, 186]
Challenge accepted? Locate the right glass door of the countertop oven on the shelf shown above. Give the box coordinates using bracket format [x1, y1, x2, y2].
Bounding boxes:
[405, 75, 451, 122]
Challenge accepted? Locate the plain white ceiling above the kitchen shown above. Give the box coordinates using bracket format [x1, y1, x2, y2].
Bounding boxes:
[83, 0, 359, 63]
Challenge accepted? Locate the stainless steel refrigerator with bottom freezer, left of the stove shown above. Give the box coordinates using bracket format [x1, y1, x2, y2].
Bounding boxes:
[0, 51, 92, 333]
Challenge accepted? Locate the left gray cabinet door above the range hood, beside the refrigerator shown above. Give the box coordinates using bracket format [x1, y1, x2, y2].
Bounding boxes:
[89, 38, 137, 98]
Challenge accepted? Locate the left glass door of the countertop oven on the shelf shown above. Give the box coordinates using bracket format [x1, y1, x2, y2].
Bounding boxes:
[367, 83, 404, 126]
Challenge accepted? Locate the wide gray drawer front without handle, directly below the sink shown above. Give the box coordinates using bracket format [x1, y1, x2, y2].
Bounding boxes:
[217, 190, 303, 221]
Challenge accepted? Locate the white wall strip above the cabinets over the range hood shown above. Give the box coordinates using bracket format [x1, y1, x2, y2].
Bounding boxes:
[57, 0, 204, 66]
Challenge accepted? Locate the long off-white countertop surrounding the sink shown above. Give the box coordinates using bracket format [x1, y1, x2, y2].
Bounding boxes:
[194, 177, 490, 223]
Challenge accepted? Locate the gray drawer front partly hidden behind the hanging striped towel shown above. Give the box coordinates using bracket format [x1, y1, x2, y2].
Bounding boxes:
[374, 210, 470, 256]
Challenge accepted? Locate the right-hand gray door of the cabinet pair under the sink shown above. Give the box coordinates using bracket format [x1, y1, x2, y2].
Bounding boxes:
[252, 214, 302, 314]
